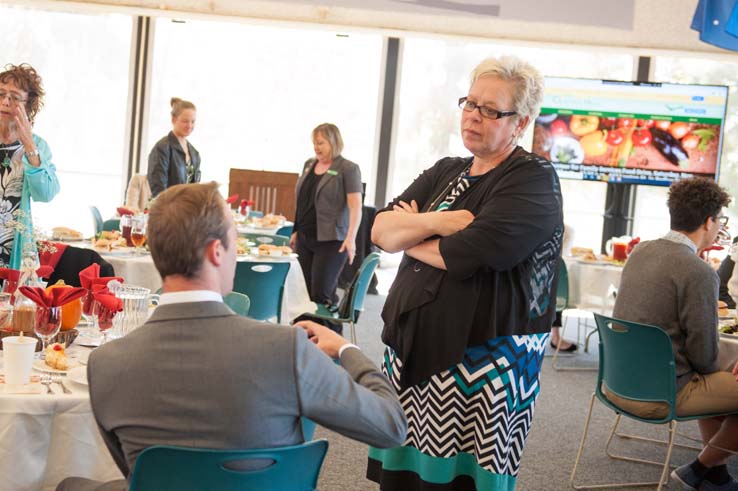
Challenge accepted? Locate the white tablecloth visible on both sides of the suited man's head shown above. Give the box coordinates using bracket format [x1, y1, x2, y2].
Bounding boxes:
[102, 250, 318, 322]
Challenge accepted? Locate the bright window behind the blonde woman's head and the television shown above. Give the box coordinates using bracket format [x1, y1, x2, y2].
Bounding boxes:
[387, 37, 633, 250]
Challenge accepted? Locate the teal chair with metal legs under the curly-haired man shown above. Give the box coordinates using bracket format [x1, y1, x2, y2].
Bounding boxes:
[570, 314, 736, 491]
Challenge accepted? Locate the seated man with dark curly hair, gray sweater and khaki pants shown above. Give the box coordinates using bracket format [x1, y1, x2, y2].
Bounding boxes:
[607, 178, 738, 490]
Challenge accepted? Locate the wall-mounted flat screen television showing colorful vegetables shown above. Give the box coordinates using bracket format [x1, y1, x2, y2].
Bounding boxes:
[533, 77, 728, 186]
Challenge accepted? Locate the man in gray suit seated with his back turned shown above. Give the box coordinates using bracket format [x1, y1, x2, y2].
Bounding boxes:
[57, 183, 407, 491]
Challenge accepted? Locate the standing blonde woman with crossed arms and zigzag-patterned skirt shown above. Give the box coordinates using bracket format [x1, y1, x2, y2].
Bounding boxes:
[367, 57, 564, 491]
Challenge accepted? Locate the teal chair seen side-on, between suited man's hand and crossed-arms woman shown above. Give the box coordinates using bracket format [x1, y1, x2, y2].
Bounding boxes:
[300, 252, 379, 344]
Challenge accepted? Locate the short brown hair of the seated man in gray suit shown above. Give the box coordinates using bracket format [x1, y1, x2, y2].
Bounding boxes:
[147, 182, 230, 278]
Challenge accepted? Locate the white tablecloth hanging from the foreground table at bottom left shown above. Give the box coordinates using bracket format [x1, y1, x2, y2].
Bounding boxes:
[0, 348, 122, 491]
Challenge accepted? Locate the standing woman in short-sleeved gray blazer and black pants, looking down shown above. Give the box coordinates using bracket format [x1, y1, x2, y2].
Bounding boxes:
[290, 123, 361, 305]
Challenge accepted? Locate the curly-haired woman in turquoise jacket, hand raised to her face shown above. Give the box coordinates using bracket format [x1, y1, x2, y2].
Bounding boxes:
[0, 63, 59, 269]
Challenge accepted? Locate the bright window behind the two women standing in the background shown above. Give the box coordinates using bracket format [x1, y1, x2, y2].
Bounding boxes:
[146, 19, 383, 208]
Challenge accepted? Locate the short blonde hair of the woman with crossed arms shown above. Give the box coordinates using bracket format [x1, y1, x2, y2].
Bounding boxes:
[470, 56, 543, 127]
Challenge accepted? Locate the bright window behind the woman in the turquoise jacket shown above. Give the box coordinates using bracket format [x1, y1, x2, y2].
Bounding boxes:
[0, 7, 133, 234]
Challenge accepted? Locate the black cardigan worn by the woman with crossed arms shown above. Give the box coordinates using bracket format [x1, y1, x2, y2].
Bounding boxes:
[382, 147, 564, 387]
